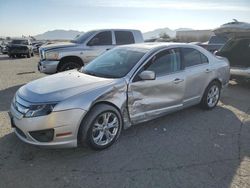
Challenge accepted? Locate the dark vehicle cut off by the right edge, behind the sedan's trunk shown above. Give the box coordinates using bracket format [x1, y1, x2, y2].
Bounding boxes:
[215, 36, 250, 78]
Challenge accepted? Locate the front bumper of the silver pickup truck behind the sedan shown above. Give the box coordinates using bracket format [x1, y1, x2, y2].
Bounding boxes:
[38, 60, 59, 74]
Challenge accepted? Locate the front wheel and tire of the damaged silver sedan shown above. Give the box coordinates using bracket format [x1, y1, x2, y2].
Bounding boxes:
[78, 104, 122, 150]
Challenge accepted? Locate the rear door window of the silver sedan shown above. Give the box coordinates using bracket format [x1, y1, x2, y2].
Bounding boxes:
[182, 48, 209, 67]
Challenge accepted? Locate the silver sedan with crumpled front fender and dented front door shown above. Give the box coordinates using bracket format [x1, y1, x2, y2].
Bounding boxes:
[10, 43, 229, 149]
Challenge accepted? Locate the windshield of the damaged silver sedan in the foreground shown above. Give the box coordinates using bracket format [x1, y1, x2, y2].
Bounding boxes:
[80, 48, 146, 78]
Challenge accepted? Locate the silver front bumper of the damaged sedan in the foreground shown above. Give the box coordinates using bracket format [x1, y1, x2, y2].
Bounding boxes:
[10, 106, 86, 148]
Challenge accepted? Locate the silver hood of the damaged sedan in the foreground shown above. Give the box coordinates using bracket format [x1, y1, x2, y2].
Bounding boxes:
[17, 70, 114, 103]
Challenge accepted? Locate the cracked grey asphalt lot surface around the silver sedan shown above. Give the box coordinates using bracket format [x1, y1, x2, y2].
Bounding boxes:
[0, 55, 250, 188]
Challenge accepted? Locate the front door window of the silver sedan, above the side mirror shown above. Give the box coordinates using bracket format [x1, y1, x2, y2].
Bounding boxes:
[145, 49, 181, 77]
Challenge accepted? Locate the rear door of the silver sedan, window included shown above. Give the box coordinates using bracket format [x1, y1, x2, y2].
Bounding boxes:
[181, 48, 213, 106]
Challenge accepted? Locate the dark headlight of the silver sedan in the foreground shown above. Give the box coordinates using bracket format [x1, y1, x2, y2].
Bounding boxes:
[24, 104, 56, 117]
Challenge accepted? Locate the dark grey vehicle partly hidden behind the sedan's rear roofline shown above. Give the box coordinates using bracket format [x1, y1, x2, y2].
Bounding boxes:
[198, 36, 228, 53]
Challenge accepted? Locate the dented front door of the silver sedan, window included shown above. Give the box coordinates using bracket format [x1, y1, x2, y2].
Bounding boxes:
[128, 49, 186, 123]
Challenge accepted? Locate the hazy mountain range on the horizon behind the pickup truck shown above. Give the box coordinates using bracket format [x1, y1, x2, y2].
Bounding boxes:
[34, 27, 192, 40]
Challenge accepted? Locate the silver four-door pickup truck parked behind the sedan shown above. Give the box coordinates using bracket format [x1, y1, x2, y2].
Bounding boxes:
[38, 29, 143, 74]
